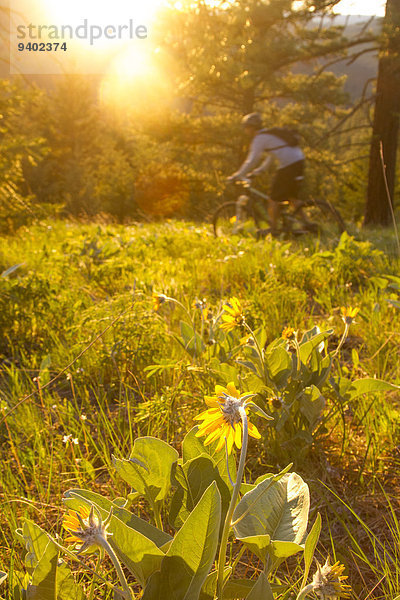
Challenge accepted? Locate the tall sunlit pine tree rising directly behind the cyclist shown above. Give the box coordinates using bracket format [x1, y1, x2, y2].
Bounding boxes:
[153, 0, 374, 211]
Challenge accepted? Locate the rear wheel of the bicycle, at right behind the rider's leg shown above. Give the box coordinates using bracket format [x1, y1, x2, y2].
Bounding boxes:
[292, 199, 346, 235]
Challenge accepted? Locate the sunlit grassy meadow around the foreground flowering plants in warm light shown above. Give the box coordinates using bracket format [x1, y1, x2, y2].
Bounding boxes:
[0, 220, 400, 600]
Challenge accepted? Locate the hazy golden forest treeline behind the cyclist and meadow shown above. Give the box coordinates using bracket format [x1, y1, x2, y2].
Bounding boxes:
[0, 0, 394, 231]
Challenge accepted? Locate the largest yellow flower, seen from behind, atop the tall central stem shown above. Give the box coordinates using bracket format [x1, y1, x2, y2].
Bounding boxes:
[195, 383, 261, 454]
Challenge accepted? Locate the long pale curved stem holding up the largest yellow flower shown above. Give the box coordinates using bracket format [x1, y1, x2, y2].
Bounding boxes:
[216, 407, 249, 600]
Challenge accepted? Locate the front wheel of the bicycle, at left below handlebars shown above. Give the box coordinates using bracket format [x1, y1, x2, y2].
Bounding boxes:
[213, 202, 257, 237]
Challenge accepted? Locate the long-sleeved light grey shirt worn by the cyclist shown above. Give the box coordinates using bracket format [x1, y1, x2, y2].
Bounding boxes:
[236, 133, 304, 177]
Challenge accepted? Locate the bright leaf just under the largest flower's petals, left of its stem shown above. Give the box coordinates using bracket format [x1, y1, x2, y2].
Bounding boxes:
[182, 426, 236, 489]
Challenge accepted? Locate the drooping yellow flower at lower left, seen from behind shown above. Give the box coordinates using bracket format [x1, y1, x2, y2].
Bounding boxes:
[63, 506, 112, 554]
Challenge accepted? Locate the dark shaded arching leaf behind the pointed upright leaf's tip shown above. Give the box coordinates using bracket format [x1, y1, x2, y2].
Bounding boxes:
[169, 454, 231, 529]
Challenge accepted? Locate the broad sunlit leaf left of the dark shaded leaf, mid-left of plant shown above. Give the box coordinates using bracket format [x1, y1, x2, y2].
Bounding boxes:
[114, 437, 179, 503]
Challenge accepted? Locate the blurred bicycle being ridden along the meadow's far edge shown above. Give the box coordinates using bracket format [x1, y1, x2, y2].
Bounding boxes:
[212, 179, 346, 238]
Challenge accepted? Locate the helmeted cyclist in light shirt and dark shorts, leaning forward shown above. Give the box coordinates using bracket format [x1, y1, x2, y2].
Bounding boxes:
[228, 113, 304, 233]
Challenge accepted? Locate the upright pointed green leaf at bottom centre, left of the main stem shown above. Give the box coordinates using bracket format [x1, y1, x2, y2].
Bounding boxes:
[143, 482, 221, 600]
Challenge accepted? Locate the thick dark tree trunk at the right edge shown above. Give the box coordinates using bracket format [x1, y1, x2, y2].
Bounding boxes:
[364, 0, 400, 226]
